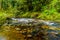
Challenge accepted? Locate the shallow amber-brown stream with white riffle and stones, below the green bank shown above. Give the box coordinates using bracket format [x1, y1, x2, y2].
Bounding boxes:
[0, 18, 60, 40]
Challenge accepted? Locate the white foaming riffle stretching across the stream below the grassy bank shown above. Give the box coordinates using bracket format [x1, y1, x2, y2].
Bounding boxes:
[4, 18, 60, 31]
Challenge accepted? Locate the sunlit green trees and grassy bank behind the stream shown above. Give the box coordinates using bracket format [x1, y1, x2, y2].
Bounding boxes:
[0, 0, 60, 24]
